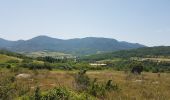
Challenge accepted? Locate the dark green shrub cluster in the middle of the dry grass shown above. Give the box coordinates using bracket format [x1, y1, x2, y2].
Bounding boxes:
[75, 70, 120, 98]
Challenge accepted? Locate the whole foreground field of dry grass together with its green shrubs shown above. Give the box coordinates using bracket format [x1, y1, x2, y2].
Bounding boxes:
[0, 68, 170, 100]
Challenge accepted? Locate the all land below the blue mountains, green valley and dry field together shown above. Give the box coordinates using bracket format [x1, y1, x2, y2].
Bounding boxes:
[0, 50, 170, 100]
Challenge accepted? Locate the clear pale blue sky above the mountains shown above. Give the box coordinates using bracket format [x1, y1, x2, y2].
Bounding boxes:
[0, 0, 170, 46]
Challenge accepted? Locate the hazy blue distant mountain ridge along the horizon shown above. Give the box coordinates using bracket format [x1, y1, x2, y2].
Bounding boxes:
[0, 36, 145, 55]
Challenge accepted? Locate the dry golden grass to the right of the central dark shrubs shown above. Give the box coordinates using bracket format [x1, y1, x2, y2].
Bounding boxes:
[89, 71, 170, 100]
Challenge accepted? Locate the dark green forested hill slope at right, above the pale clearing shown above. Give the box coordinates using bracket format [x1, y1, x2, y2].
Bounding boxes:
[82, 46, 170, 60]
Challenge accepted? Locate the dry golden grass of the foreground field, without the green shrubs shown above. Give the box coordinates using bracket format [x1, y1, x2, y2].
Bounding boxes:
[0, 69, 170, 100]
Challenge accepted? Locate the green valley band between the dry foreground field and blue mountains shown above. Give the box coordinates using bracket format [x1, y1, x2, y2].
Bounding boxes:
[0, 47, 170, 72]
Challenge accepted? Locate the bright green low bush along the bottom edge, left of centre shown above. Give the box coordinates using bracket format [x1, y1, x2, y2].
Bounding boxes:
[32, 87, 96, 100]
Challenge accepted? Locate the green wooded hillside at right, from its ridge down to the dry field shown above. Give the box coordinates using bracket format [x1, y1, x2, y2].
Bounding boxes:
[80, 46, 170, 72]
